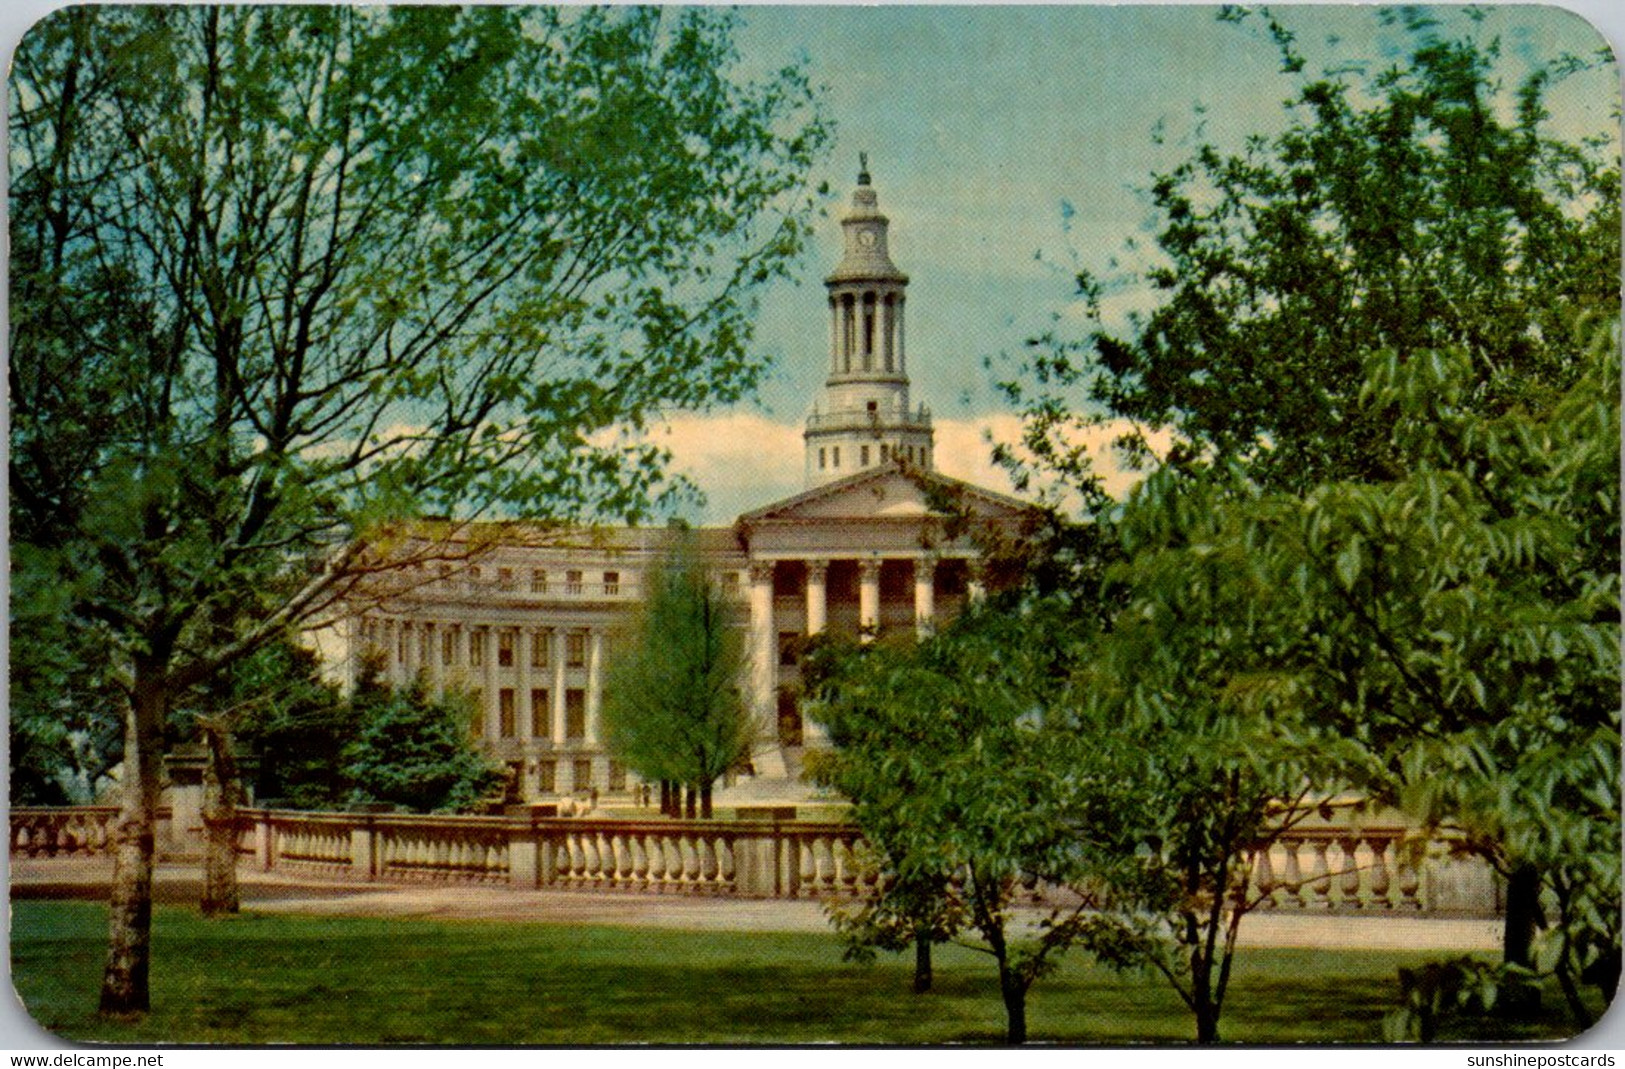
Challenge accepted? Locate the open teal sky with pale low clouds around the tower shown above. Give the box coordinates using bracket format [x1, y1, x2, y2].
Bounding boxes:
[640, 5, 1619, 523]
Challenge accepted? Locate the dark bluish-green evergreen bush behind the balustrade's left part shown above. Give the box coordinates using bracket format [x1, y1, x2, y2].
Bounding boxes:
[343, 663, 504, 812]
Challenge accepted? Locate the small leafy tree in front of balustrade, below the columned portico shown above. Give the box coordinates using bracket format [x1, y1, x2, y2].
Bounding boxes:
[809, 611, 1112, 1043]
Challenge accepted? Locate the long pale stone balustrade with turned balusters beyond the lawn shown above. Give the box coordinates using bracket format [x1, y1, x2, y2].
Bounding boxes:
[11, 806, 1503, 916]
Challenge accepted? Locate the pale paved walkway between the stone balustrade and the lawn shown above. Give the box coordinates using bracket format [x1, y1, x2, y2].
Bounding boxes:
[11, 858, 1502, 952]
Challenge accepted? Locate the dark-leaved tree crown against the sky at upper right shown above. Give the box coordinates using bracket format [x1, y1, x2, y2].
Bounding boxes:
[1006, 10, 1620, 492]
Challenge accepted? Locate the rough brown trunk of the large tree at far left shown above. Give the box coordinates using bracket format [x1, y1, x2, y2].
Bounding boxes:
[99, 661, 167, 1017]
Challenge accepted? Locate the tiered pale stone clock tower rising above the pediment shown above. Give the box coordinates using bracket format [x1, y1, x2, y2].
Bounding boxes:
[803, 153, 931, 486]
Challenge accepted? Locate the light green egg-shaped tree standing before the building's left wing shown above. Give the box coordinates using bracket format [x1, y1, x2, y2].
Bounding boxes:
[603, 531, 757, 819]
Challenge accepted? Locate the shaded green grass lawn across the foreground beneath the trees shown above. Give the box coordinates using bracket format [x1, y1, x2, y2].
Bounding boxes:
[11, 902, 1592, 1046]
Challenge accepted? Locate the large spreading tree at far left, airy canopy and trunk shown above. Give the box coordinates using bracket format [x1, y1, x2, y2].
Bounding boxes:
[8, 6, 827, 1014]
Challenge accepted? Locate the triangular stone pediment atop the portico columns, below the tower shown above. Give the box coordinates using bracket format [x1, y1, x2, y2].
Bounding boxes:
[739, 465, 1032, 526]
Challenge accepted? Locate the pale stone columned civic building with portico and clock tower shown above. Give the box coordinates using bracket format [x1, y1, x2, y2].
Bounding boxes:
[346, 167, 1029, 799]
